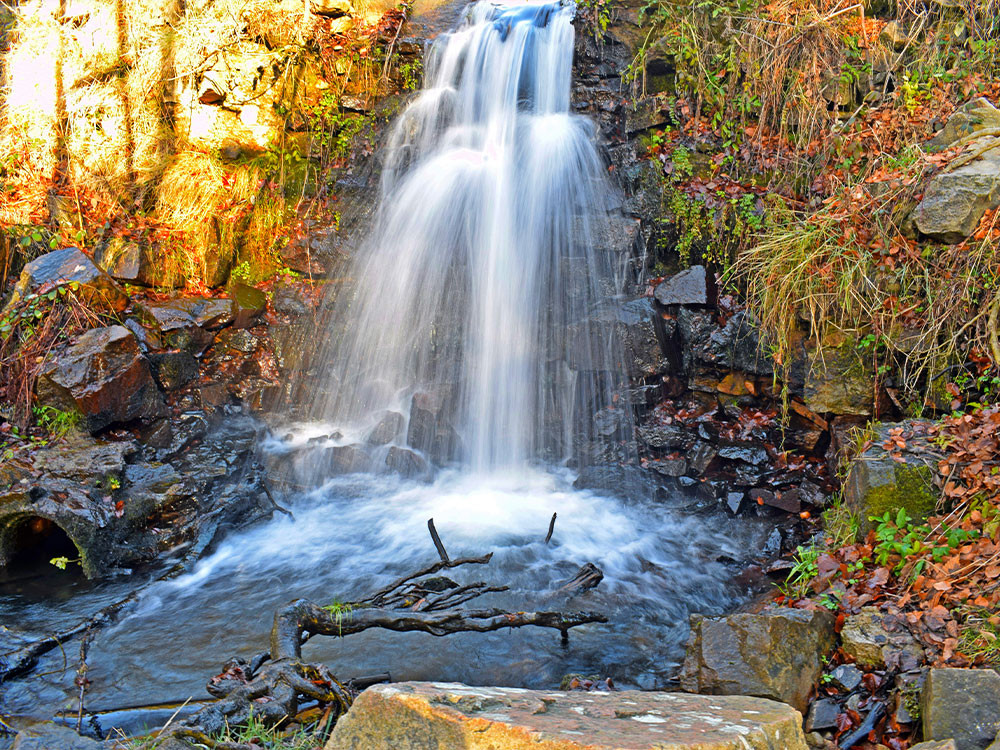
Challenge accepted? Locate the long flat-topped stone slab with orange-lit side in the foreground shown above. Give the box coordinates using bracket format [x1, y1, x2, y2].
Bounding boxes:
[325, 682, 806, 750]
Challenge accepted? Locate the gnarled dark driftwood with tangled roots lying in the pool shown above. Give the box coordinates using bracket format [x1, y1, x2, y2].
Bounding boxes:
[161, 548, 607, 750]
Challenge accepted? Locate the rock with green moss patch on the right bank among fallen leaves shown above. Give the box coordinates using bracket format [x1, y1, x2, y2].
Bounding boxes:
[844, 423, 939, 530]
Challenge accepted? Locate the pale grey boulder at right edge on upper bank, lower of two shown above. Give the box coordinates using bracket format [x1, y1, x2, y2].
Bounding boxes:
[912, 142, 1000, 244]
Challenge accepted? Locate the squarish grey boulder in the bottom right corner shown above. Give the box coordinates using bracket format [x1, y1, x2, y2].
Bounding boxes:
[920, 669, 1000, 750]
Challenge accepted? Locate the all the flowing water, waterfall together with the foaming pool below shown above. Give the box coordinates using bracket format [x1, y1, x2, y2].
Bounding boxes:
[0, 2, 772, 728]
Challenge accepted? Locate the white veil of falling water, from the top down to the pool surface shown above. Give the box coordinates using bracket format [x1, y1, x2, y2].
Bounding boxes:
[311, 0, 623, 471]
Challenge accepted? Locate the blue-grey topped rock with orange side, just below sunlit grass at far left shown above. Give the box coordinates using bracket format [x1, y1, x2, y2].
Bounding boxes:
[8, 247, 128, 312]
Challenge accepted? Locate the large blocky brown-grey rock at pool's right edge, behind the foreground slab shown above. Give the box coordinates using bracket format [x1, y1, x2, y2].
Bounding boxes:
[680, 608, 836, 712]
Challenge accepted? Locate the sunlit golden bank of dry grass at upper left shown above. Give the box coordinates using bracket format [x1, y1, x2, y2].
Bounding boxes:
[0, 0, 412, 286]
